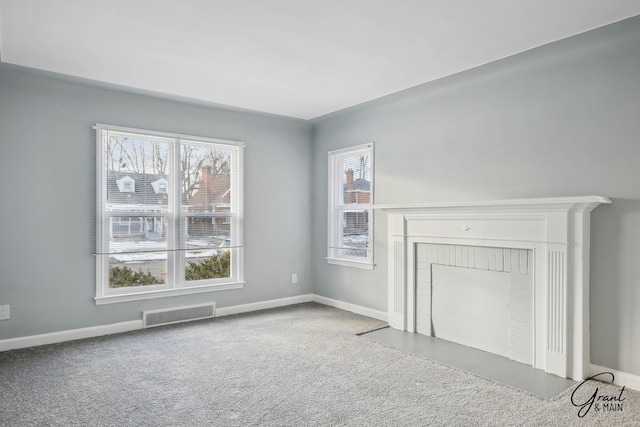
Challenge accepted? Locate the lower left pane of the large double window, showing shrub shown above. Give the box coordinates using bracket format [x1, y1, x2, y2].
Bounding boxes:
[109, 216, 167, 288]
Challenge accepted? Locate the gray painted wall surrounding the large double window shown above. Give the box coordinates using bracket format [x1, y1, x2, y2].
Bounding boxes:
[0, 65, 312, 339]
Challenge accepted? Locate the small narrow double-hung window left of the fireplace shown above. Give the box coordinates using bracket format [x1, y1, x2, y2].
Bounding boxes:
[327, 143, 373, 268]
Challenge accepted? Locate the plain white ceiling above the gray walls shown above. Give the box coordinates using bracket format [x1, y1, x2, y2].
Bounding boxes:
[0, 0, 640, 119]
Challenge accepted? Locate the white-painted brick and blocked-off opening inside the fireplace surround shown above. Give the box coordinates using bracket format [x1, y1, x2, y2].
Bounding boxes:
[415, 243, 533, 365]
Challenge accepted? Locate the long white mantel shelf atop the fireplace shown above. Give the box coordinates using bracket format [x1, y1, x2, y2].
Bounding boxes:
[373, 196, 611, 212]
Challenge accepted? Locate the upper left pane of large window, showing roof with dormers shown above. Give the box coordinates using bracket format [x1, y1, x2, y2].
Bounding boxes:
[104, 135, 170, 212]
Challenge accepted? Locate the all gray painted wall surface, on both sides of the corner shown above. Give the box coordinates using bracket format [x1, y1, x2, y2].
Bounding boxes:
[0, 18, 640, 375]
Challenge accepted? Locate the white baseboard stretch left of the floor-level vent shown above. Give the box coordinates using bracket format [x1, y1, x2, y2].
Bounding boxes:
[0, 320, 142, 351]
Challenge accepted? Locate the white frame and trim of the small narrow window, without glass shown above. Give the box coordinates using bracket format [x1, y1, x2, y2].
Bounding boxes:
[325, 142, 375, 270]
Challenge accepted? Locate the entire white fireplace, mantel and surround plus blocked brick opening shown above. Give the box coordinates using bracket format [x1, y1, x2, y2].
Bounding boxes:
[376, 196, 611, 380]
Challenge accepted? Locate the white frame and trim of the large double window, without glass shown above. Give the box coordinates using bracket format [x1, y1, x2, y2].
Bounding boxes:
[94, 124, 245, 305]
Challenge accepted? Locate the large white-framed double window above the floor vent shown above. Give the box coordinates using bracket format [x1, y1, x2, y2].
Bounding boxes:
[95, 125, 244, 304]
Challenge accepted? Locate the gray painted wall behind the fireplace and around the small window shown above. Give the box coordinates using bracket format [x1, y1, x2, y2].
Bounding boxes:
[313, 18, 640, 375]
